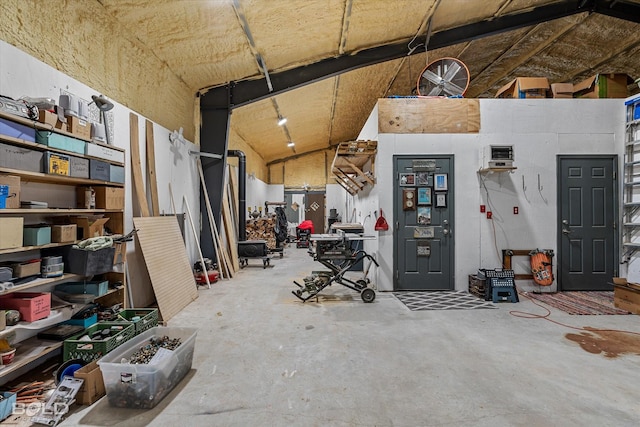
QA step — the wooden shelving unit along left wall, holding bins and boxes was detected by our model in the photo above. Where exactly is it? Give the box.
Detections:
[0,113,126,385]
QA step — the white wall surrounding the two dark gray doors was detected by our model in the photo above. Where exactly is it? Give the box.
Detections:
[345,99,624,290]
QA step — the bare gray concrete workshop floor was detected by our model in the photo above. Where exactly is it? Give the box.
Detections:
[61,247,640,427]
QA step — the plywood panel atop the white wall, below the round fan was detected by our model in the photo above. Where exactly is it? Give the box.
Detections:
[378,98,480,133]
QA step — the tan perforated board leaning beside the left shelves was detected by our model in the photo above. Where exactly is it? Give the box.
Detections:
[133,216,198,322]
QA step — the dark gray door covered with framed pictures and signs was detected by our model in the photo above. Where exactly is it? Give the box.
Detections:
[393,155,454,291]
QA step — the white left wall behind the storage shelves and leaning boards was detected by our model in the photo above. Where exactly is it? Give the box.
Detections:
[0,40,200,262]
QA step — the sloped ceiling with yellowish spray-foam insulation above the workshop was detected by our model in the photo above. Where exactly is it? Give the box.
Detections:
[99,0,640,163]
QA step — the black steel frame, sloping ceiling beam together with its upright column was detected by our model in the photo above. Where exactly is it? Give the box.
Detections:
[199,0,640,251]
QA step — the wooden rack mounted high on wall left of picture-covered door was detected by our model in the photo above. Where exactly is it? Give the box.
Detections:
[331,141,378,195]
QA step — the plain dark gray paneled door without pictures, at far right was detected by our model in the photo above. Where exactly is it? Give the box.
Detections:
[557,156,618,291]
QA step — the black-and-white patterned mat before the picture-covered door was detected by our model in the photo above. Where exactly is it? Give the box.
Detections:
[393,291,498,311]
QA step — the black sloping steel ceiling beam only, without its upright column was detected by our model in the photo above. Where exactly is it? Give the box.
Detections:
[201,0,600,110]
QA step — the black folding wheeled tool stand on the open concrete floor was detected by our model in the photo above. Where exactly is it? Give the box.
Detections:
[292,230,378,303]
